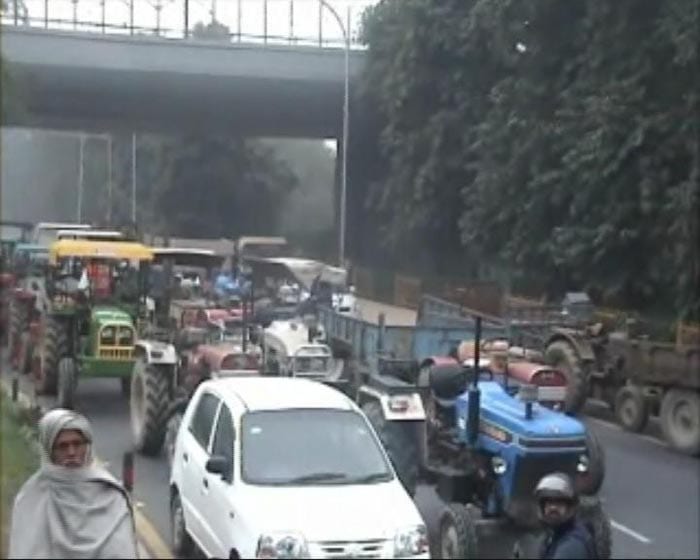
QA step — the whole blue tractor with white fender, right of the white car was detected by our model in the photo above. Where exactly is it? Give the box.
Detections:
[358,317,611,558]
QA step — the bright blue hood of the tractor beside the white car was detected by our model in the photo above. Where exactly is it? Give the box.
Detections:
[457,381,586,441]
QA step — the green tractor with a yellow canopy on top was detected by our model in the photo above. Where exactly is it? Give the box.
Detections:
[32,239,153,408]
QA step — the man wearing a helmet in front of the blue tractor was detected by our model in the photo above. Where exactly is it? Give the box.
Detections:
[535,473,597,560]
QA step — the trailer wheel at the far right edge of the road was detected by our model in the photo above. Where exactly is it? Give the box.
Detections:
[661,389,700,455]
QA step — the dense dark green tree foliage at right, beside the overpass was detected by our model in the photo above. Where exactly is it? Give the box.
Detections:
[363,0,700,320]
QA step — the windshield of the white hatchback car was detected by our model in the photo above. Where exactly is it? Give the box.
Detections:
[241,409,394,485]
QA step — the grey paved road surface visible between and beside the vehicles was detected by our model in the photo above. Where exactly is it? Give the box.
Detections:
[6,366,700,558]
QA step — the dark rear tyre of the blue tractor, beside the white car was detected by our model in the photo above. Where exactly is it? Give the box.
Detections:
[362,400,419,496]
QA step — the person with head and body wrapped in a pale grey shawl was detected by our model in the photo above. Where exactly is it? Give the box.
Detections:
[8,408,138,558]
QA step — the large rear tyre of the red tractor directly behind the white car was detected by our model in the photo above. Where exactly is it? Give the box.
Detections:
[129,357,170,455]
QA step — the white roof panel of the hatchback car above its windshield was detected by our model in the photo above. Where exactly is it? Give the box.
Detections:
[202,377,354,411]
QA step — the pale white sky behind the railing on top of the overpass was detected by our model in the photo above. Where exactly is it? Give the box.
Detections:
[17,0,379,41]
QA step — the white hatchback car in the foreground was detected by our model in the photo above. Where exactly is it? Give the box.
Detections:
[170,377,430,558]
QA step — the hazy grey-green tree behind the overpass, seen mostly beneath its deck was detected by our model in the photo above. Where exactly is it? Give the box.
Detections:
[98,22,297,241]
